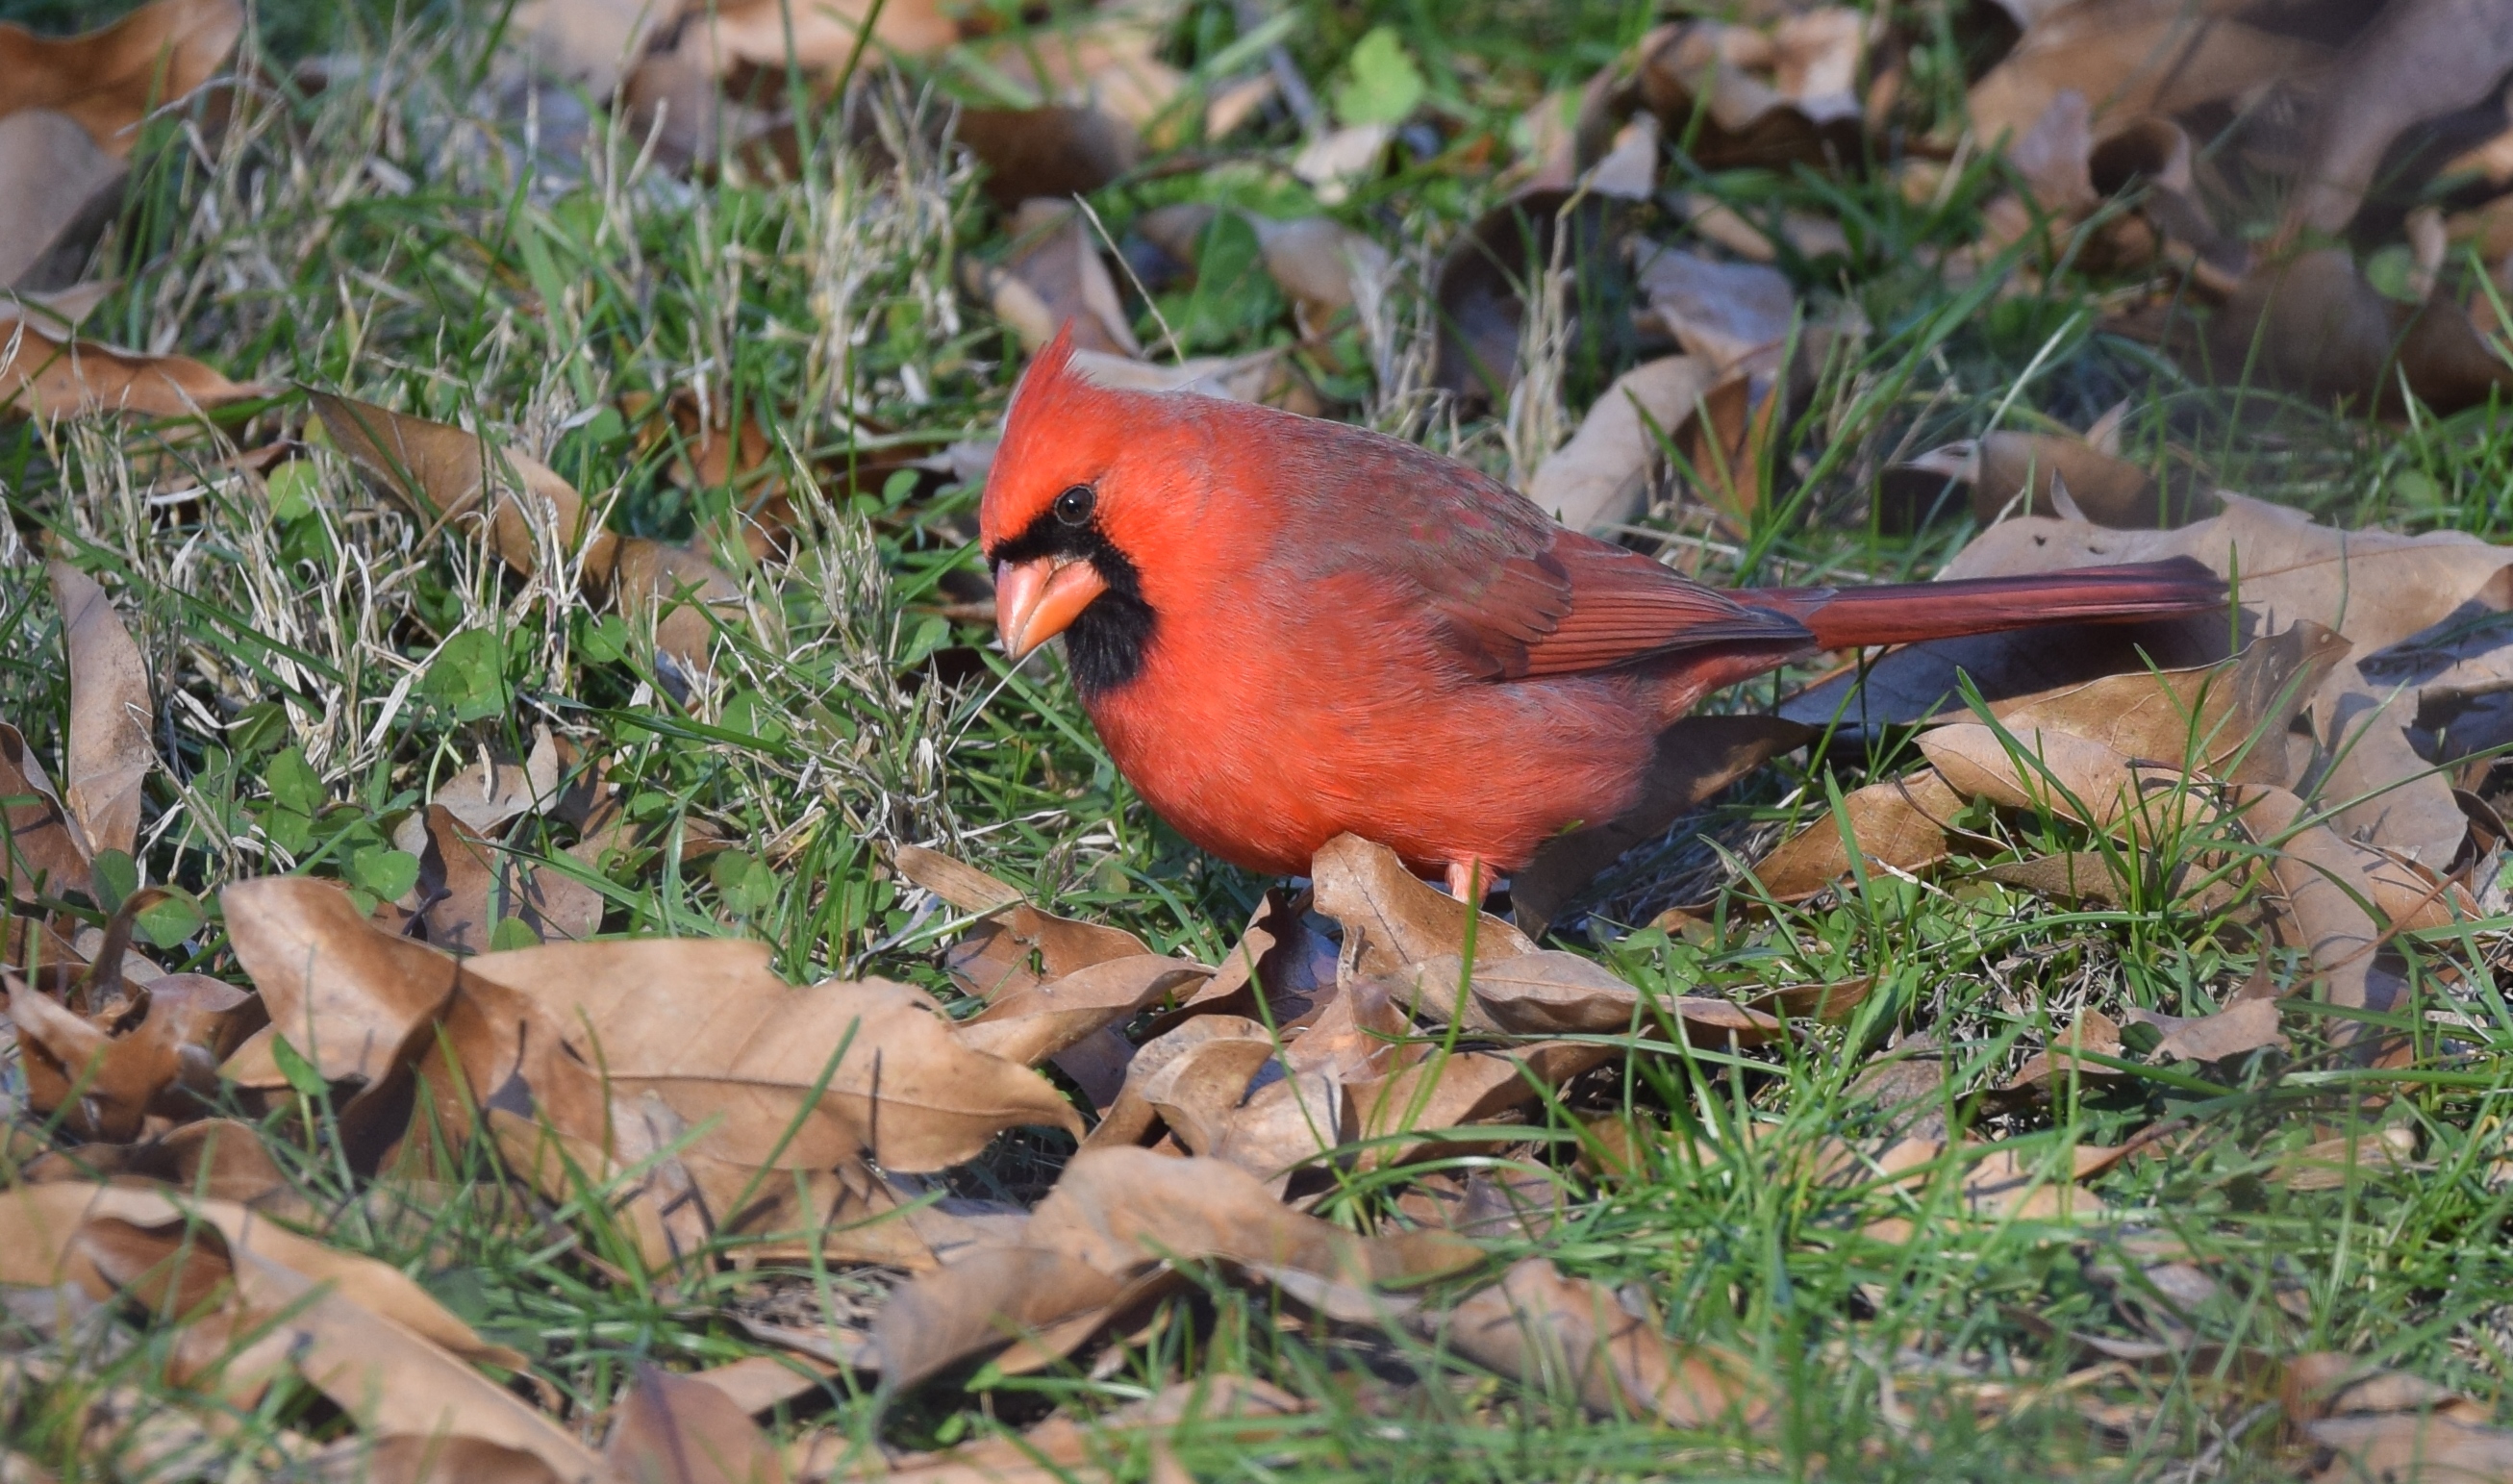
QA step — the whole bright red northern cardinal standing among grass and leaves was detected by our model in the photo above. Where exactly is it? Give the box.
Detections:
[977,337,2224,896]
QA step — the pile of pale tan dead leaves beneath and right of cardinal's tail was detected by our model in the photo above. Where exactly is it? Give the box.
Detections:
[1756,494,2513,1055]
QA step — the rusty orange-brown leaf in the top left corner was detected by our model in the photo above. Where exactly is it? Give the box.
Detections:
[0,0,243,156]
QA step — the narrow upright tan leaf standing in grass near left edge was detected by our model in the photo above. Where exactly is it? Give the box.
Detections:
[45,560,156,854]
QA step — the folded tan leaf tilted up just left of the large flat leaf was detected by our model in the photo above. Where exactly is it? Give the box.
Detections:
[218,876,455,1087]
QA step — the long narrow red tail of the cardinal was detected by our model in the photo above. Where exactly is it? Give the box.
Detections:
[1737,558,2226,650]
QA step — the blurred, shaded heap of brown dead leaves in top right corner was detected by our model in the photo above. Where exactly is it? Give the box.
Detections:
[1949,0,2513,412]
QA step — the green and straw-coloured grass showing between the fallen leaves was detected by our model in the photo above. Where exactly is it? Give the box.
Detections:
[0,0,2513,1479]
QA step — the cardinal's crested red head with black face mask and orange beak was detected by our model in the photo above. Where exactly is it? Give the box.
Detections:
[977,332,1173,695]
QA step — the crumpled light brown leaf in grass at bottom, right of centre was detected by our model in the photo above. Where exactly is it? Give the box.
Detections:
[1440,1258,1770,1429]
